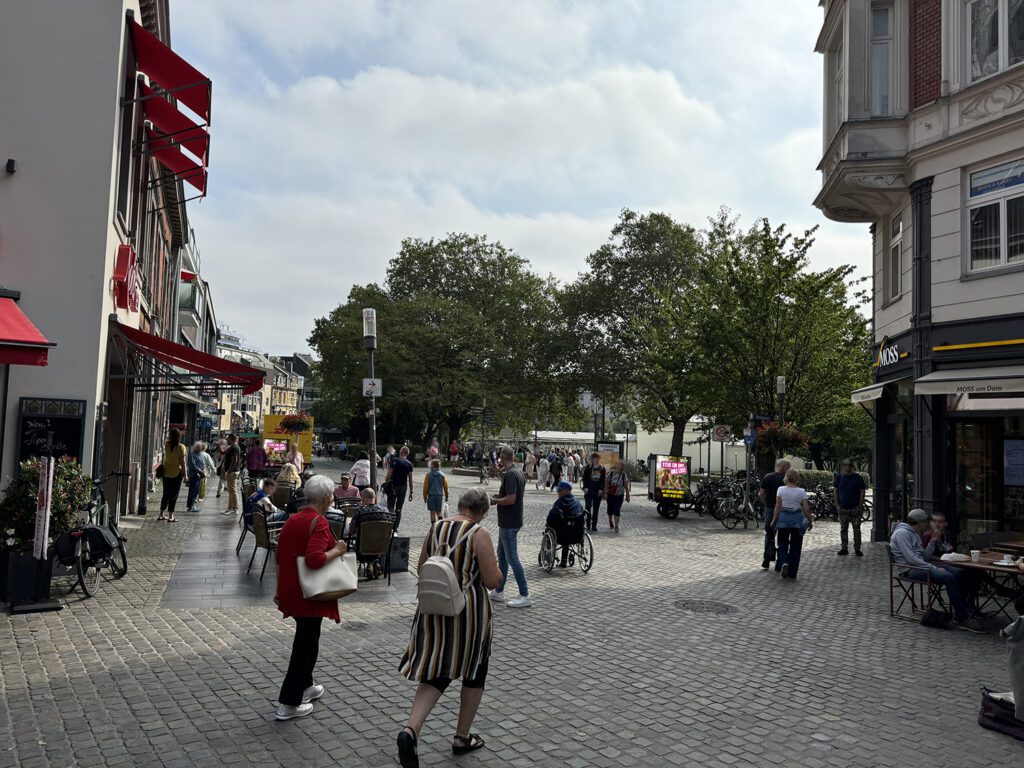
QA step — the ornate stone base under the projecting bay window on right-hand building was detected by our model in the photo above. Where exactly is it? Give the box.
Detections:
[814,118,907,222]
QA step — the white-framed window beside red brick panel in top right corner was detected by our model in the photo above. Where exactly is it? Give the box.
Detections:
[967,0,1024,81]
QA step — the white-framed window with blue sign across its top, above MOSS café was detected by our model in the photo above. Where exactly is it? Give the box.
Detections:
[967,160,1024,271]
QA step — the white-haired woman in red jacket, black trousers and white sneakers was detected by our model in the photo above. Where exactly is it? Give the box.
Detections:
[273,475,346,720]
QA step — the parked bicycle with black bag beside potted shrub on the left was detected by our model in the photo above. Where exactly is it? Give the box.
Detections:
[53,472,128,597]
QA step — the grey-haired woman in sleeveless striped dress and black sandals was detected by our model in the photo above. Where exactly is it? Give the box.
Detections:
[398,488,502,768]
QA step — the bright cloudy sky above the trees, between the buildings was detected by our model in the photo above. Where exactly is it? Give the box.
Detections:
[171,0,869,354]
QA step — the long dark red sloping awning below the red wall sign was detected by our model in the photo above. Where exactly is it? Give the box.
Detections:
[111,317,265,397]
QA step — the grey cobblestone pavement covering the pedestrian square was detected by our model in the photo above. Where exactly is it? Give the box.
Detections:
[0,465,1024,768]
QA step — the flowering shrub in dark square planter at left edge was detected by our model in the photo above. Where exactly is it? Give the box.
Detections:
[0,456,92,603]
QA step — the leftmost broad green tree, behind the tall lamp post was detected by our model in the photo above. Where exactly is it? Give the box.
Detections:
[309,233,572,444]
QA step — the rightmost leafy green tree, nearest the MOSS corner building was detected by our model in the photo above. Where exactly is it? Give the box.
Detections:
[701,210,869,469]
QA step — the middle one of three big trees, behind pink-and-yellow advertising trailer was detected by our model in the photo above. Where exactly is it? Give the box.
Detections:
[562,210,707,455]
